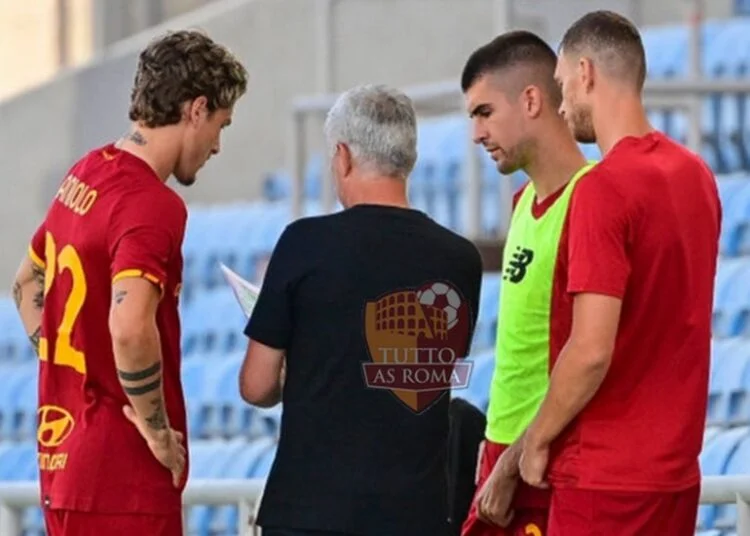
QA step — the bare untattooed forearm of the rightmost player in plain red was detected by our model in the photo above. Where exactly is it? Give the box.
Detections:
[527,345,609,446]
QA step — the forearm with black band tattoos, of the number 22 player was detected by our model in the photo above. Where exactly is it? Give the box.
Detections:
[113,325,169,440]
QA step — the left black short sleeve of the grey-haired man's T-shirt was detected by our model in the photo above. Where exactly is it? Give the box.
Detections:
[245,224,304,350]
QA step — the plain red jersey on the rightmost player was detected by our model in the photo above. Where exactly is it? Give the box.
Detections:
[549,133,721,491]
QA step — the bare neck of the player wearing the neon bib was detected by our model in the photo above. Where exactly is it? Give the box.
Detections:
[525,133,586,202]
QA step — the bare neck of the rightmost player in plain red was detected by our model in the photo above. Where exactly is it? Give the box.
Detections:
[593,94,653,155]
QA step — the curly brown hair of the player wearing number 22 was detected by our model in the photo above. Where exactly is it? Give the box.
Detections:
[128,30,248,128]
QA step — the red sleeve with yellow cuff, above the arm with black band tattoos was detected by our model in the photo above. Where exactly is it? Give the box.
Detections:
[110,186,187,289]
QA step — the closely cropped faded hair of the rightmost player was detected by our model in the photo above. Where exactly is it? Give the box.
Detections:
[560,10,646,89]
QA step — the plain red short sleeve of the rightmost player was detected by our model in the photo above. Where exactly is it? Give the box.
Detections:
[568,172,630,298]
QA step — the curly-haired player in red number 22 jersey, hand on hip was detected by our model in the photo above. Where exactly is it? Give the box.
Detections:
[13,31,247,536]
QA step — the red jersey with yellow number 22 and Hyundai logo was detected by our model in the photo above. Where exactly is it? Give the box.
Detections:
[29,145,187,514]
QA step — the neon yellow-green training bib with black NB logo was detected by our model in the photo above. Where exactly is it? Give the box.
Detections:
[486,163,594,445]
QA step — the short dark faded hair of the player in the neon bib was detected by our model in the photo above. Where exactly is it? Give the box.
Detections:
[461,30,560,106]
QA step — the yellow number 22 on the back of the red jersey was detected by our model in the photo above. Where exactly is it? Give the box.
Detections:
[39,231,87,374]
